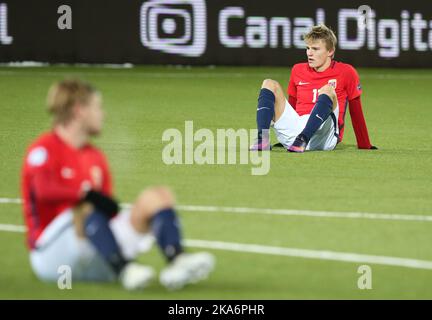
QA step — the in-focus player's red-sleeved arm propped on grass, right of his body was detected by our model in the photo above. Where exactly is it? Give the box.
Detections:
[349,96,377,149]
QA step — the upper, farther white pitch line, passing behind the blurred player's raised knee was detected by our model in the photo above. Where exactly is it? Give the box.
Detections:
[0,198,432,222]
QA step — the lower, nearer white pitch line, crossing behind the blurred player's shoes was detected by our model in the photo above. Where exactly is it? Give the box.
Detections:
[0,224,432,270]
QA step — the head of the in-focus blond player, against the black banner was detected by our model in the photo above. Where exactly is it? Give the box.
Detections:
[304,24,337,71]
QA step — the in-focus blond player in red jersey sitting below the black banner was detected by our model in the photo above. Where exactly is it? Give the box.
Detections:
[250,25,376,152]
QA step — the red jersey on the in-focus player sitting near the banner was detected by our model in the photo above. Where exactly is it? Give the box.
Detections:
[288,61,362,135]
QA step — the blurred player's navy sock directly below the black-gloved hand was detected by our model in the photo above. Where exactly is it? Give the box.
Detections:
[85,211,128,275]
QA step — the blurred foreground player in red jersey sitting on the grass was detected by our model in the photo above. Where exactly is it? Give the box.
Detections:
[22,80,214,290]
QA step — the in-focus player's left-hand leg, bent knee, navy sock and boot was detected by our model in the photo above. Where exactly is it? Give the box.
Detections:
[250,79,285,151]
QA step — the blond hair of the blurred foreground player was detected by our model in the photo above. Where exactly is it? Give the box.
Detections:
[47,79,97,124]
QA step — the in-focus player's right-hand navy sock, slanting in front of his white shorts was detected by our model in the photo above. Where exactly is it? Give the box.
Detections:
[299,94,333,142]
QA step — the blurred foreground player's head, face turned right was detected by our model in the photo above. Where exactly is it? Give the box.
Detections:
[47,80,104,136]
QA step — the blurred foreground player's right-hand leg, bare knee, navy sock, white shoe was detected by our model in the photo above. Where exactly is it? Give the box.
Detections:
[131,187,214,289]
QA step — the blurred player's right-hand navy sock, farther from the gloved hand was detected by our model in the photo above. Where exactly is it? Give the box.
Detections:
[151,208,183,262]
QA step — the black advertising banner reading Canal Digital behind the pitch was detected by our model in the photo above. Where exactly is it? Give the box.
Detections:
[0,0,432,67]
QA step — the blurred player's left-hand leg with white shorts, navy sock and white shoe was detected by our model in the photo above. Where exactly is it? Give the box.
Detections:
[30,209,154,289]
